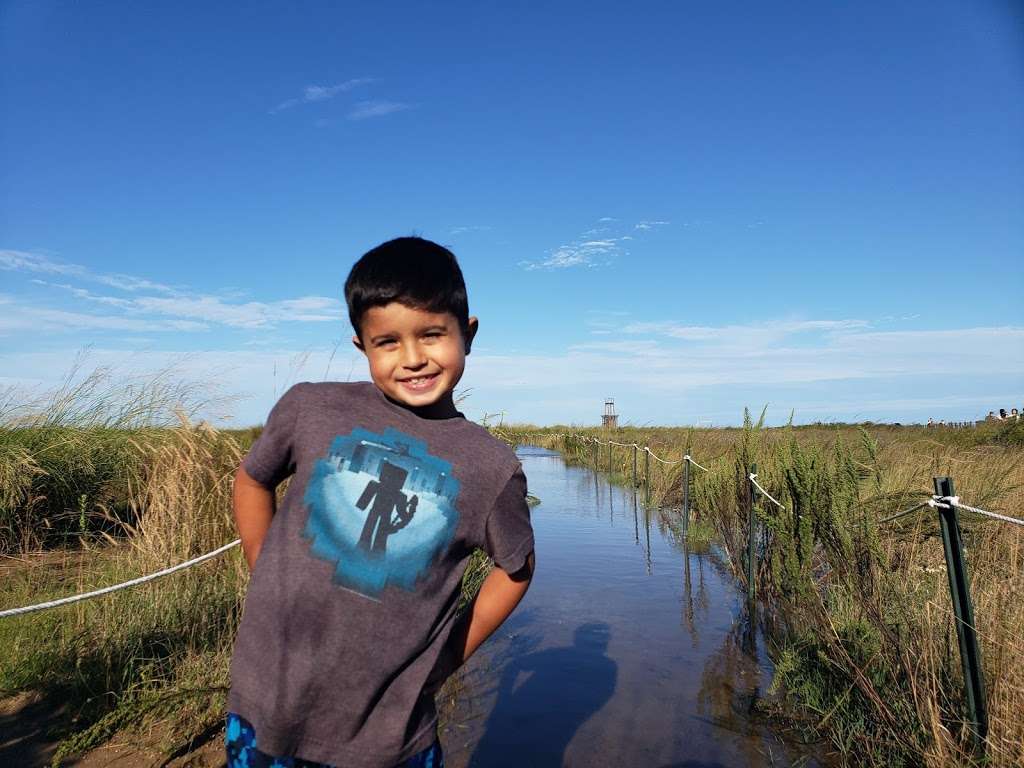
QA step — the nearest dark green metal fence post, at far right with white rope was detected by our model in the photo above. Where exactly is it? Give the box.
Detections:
[932,477,988,753]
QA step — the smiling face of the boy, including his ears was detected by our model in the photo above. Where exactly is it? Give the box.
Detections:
[352,301,477,415]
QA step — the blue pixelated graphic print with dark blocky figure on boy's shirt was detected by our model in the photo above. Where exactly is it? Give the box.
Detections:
[303,427,459,597]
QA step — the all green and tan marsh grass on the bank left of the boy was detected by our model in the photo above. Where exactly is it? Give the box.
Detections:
[0,367,490,764]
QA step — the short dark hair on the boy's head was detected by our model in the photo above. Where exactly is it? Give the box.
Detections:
[345,238,469,338]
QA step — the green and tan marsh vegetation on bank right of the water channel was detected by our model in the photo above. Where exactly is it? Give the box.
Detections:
[505,416,1024,767]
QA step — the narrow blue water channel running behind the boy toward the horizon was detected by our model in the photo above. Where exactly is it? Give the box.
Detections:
[441,446,816,768]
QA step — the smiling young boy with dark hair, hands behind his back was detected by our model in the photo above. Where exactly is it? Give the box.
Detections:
[226,238,534,768]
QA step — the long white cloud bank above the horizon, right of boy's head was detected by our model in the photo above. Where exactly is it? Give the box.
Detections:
[464,321,1024,397]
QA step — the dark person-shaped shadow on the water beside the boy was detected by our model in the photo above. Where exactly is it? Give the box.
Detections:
[469,622,617,768]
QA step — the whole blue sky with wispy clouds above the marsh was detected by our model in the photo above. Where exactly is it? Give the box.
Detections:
[0,0,1024,424]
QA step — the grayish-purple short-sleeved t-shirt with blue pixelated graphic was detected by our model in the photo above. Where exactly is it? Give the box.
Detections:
[227,382,534,768]
